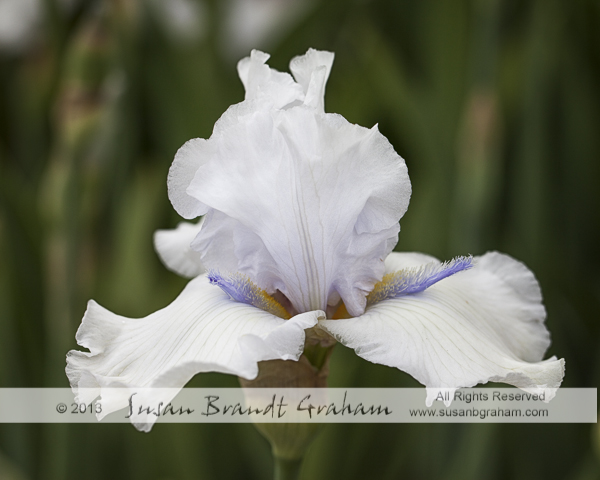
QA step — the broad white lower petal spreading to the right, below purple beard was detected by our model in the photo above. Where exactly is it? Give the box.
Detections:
[319,252,564,403]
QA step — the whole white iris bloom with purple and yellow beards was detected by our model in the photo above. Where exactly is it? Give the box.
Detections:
[67,49,564,432]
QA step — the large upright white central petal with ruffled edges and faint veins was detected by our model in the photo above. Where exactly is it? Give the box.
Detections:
[169,107,410,315]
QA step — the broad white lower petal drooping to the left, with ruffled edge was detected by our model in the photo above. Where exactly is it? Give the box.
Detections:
[66,276,325,429]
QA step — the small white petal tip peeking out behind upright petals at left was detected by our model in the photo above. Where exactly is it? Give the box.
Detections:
[154,217,206,278]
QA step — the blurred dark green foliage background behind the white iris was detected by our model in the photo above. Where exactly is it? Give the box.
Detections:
[0,0,600,480]
